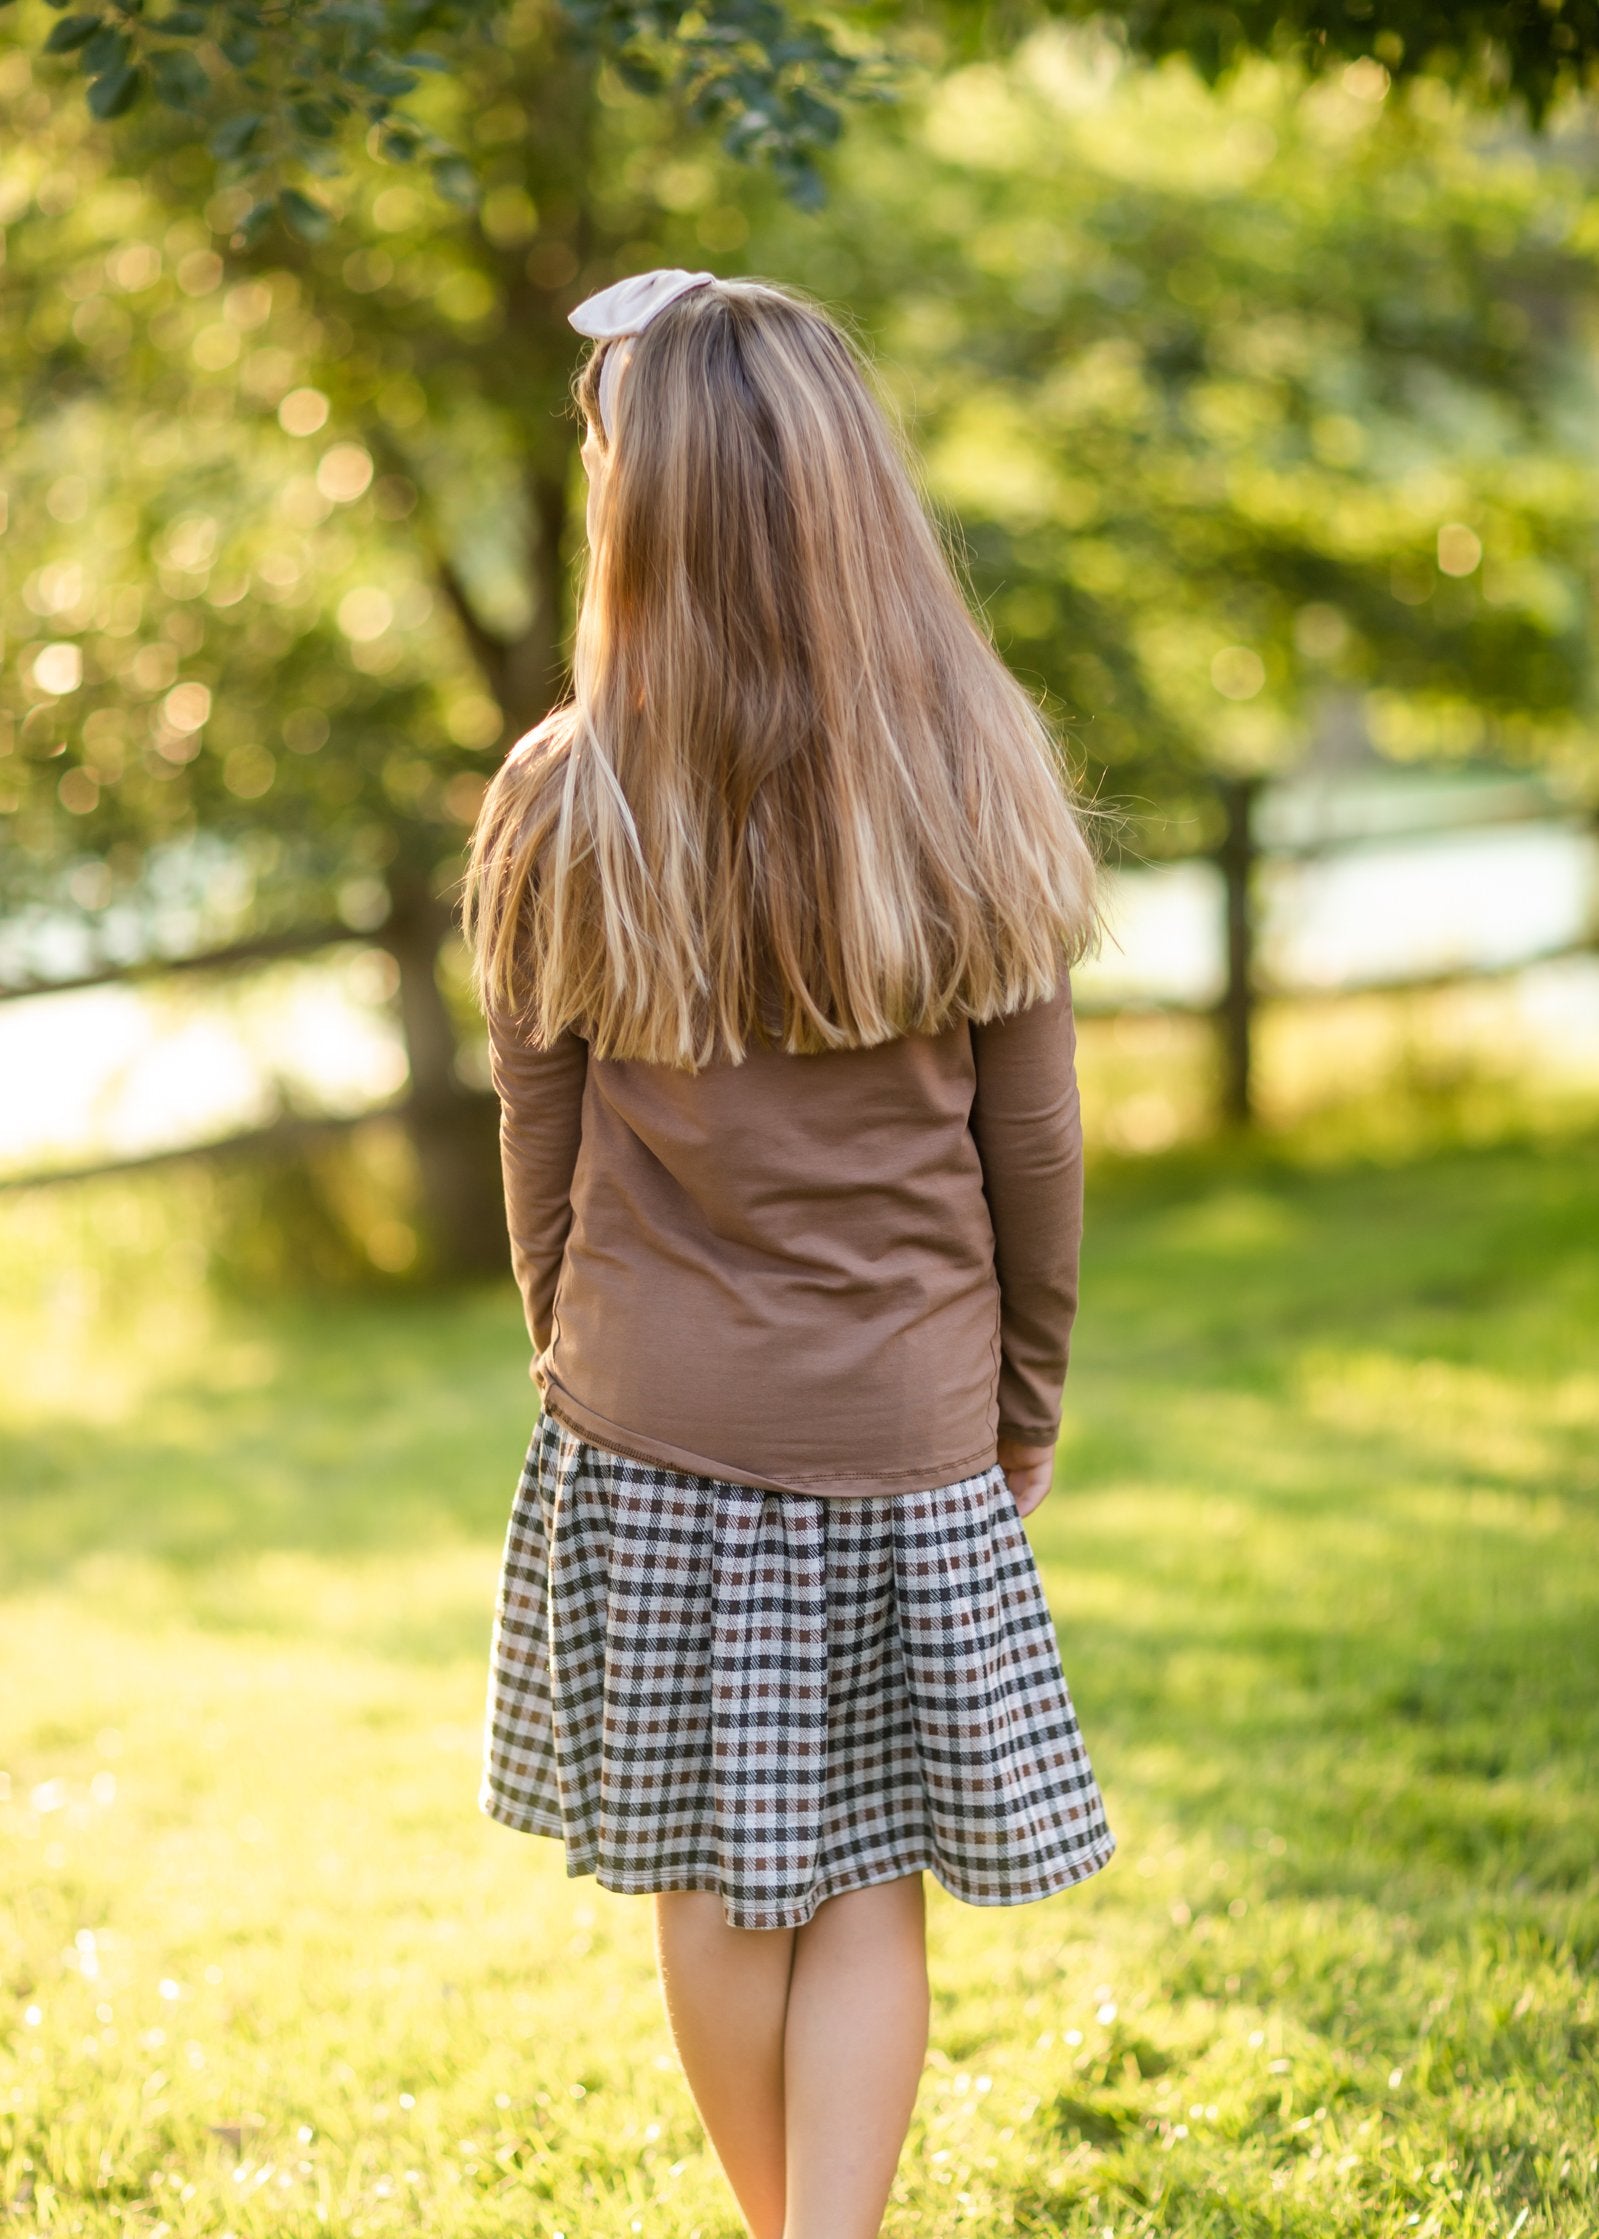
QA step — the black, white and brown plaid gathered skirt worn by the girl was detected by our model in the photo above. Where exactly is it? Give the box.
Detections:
[479,1415,1115,1928]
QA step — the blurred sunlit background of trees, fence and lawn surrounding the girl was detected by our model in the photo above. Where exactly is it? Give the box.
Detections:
[0,17,1599,2239]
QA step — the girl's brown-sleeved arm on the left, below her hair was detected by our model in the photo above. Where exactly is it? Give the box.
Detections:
[488,1010,589,1377]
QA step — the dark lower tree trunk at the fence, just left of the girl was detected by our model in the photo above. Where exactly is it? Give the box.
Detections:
[383,878,508,1274]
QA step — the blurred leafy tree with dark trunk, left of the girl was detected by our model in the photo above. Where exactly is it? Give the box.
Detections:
[0,9,739,1263]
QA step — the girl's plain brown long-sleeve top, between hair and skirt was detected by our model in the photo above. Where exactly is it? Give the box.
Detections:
[488,974,1082,1496]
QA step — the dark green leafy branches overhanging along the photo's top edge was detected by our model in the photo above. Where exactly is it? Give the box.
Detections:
[21,0,1599,244]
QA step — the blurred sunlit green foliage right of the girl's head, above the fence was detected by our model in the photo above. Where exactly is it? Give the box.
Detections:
[752,31,1599,851]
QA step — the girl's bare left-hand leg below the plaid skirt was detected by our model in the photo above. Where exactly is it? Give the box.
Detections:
[656,1890,792,2239]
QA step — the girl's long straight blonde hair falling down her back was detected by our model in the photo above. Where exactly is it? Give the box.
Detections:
[464,282,1097,1070]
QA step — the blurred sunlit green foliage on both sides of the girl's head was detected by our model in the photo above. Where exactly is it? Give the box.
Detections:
[0,31,1599,952]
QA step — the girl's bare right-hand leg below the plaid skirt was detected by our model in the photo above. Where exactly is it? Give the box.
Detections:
[782,1874,929,2239]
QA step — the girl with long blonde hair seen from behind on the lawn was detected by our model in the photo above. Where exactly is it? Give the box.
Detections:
[466,271,1115,2239]
